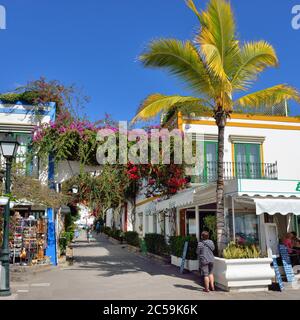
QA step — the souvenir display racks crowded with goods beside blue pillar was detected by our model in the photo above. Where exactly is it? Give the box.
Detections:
[9,206,50,266]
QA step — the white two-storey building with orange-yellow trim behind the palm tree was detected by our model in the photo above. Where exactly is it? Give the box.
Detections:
[121,114,300,253]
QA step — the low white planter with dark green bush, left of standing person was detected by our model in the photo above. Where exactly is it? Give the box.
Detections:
[170,236,199,271]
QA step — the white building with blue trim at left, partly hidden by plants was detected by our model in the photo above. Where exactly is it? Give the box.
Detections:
[0,102,57,265]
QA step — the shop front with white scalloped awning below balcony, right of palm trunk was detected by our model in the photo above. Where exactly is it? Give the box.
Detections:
[225,180,300,257]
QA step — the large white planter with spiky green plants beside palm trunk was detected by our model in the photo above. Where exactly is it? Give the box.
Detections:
[214,242,275,292]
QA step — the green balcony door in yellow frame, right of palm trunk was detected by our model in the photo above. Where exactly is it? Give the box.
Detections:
[235,143,262,179]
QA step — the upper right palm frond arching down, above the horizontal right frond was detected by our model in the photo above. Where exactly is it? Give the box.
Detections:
[231,41,278,90]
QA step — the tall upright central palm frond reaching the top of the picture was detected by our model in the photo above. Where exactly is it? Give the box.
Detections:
[196,0,240,82]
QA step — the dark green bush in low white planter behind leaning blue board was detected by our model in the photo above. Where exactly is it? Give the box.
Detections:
[170,236,198,260]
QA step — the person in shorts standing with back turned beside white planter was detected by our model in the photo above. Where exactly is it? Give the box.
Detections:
[198,231,215,292]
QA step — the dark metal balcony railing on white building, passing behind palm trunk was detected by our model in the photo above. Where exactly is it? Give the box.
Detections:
[192,161,278,183]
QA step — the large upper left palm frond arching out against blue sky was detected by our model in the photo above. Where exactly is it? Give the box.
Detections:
[140,39,213,94]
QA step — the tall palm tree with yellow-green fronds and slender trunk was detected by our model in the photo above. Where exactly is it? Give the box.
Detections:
[133,0,300,253]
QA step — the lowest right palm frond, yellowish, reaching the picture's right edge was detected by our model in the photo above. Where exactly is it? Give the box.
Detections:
[235,84,300,108]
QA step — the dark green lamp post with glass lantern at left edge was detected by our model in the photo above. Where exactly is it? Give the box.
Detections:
[0,135,19,296]
